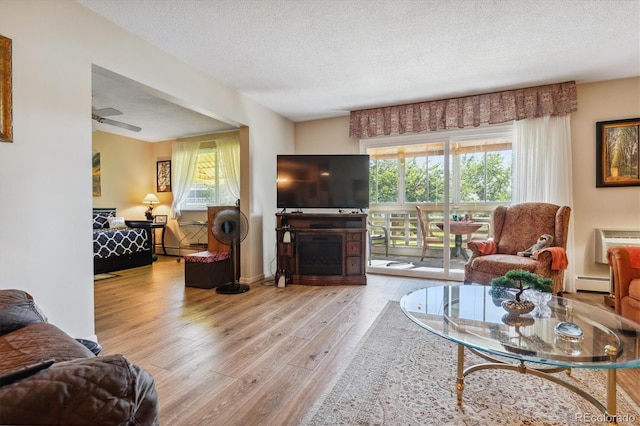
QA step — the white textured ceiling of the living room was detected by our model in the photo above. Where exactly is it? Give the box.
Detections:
[81,0,640,141]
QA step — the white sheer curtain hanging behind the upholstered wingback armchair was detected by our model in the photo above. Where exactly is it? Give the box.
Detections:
[513,114,576,292]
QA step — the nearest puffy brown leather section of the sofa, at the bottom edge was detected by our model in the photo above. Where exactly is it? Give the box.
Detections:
[0,355,158,425]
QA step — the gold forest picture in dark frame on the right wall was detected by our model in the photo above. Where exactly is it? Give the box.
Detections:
[596,118,640,188]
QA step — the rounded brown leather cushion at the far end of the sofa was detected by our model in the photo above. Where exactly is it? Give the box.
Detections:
[0,289,47,335]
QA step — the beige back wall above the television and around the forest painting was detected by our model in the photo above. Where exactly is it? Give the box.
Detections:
[295,78,640,288]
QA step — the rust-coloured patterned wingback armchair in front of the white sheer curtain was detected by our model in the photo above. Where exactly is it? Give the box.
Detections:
[464,203,571,294]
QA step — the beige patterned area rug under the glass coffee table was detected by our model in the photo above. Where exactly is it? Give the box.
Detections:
[302,302,640,426]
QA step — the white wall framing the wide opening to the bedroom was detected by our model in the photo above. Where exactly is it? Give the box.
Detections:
[0,0,293,336]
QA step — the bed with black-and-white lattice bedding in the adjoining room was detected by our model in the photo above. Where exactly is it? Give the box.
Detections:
[93,208,152,274]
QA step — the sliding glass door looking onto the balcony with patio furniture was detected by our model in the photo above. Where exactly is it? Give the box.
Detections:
[361,126,511,280]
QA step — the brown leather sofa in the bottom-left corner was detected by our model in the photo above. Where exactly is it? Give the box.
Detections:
[0,290,158,425]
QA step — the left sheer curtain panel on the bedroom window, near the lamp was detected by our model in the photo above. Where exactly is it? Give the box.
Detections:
[171,141,200,219]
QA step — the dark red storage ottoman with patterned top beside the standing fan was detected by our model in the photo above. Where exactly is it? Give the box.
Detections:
[184,251,233,288]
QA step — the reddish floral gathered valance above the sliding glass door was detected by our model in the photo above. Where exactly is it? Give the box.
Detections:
[349,81,578,138]
